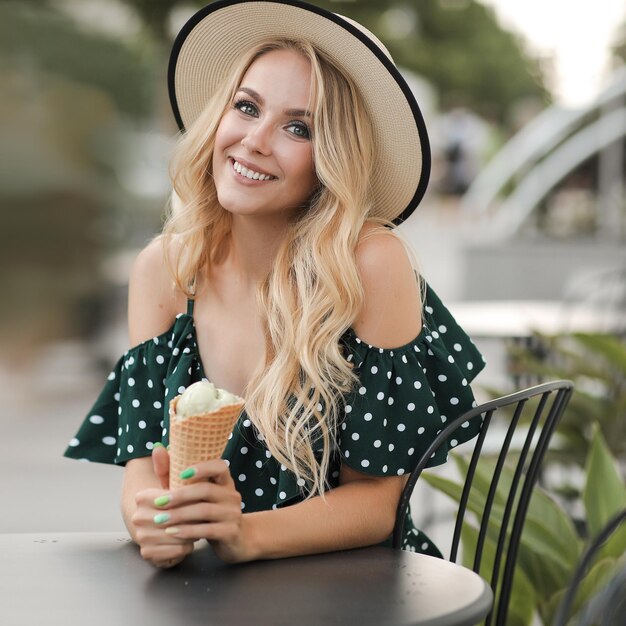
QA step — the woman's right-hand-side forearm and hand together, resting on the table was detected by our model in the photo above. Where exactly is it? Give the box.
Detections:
[149,460,406,563]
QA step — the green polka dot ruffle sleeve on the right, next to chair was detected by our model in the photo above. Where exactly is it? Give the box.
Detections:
[339,280,484,476]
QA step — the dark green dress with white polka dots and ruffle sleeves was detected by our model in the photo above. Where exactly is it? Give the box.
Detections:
[65,280,484,556]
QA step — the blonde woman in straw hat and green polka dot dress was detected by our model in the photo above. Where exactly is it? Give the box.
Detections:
[66,1,482,567]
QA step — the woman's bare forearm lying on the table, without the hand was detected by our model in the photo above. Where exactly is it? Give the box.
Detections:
[242,480,399,560]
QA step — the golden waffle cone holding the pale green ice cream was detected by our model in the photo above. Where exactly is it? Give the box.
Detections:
[169,396,243,489]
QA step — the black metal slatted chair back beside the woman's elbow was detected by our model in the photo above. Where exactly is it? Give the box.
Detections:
[392,380,574,626]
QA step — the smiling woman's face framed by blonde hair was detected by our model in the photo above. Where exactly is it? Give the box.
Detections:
[213,50,317,216]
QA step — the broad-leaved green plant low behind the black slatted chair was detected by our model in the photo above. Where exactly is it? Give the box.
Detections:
[423,424,626,626]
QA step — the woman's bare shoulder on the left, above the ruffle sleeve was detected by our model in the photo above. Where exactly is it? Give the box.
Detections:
[128,237,185,345]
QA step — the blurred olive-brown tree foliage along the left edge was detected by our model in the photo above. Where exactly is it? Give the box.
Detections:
[0,0,158,355]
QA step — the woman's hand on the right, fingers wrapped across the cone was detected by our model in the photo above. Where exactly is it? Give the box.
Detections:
[153,460,251,563]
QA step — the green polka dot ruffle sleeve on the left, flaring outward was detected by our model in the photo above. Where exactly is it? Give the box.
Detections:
[65,314,201,465]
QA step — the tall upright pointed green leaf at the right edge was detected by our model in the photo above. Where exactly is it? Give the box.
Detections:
[583,423,626,536]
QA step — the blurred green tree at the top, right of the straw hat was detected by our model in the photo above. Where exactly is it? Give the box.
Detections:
[318,0,550,123]
